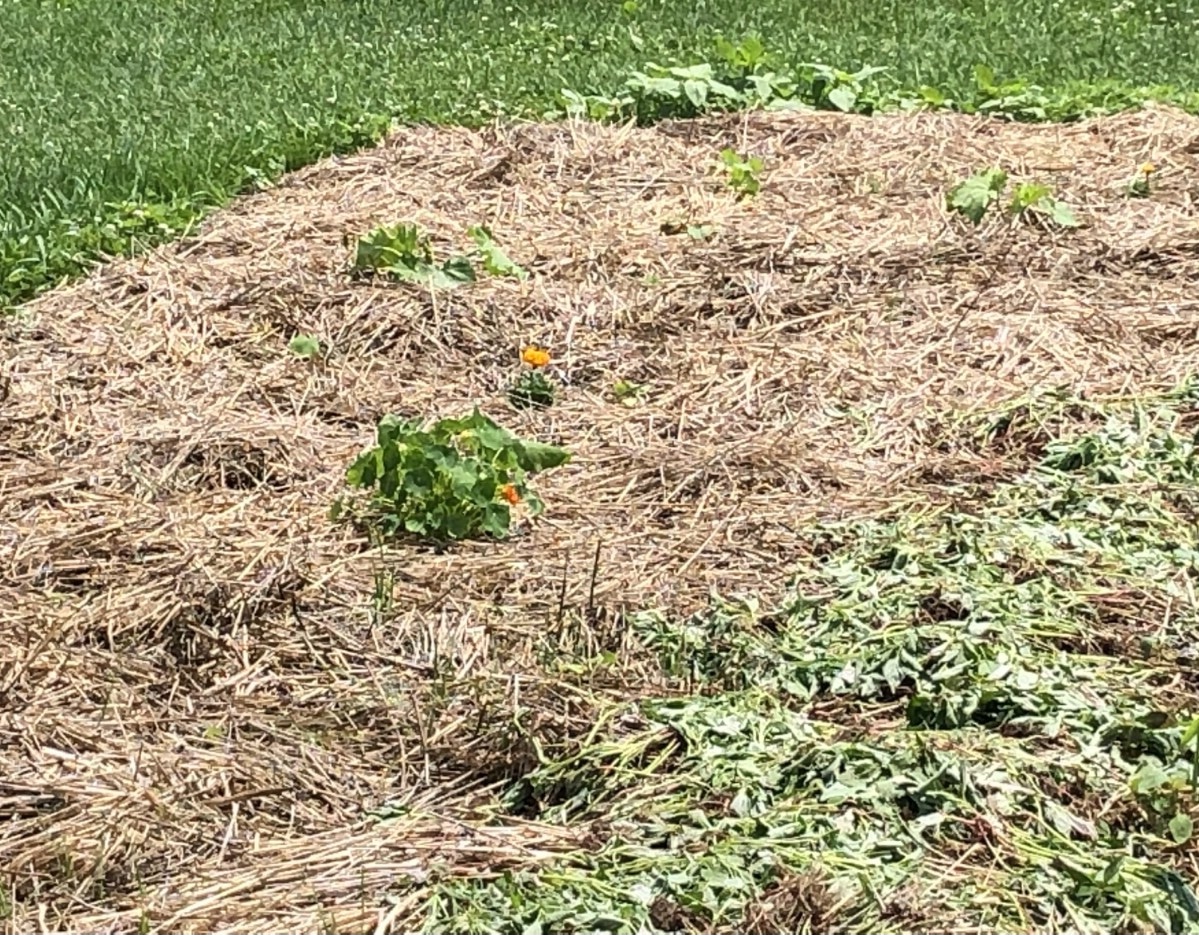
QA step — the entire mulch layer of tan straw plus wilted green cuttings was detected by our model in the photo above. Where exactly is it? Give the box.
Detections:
[0,109,1199,933]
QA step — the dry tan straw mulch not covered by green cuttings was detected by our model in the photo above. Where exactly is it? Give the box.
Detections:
[0,102,1199,933]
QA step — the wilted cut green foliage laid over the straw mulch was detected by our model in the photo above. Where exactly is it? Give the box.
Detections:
[423,381,1199,935]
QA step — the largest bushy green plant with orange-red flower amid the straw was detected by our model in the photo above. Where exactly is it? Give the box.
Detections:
[335,406,571,539]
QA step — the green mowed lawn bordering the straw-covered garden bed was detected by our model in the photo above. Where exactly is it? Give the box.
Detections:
[0,0,1199,303]
